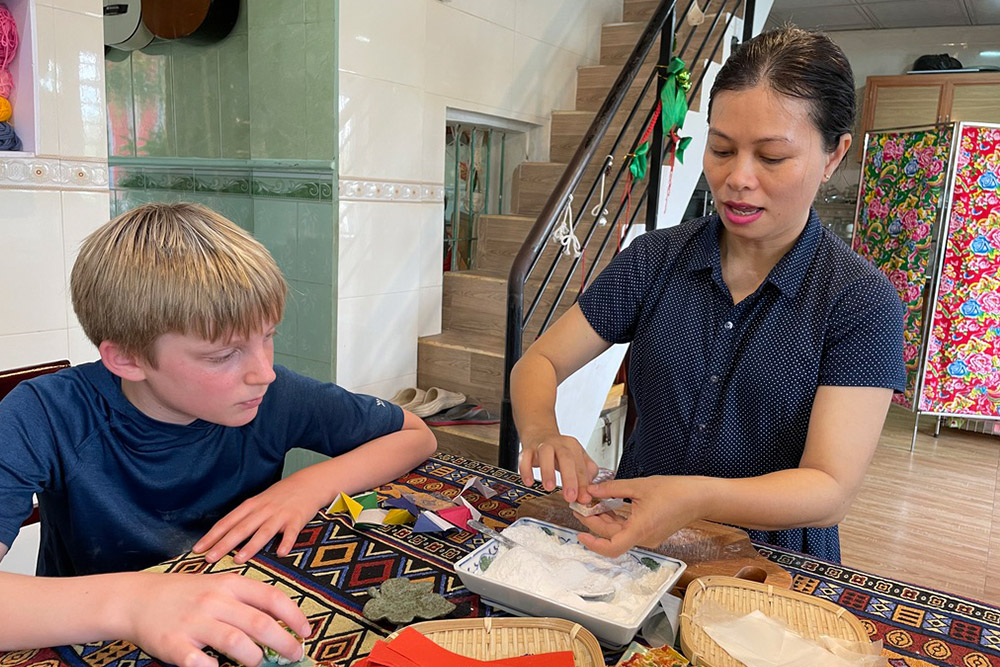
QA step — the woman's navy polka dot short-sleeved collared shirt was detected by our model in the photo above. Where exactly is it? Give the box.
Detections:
[580,211,906,562]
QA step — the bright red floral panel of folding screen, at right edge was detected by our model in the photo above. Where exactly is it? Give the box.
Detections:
[919,123,1000,418]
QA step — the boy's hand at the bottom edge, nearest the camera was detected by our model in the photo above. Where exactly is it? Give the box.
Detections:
[123,572,312,667]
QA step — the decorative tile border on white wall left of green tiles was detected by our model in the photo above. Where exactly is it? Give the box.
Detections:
[0,159,108,191]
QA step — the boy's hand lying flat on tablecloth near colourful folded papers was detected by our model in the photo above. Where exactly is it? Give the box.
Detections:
[192,475,323,563]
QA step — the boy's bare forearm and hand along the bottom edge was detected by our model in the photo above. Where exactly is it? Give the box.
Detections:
[0,564,311,667]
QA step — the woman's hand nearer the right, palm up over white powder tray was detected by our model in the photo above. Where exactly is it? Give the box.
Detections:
[576,475,704,558]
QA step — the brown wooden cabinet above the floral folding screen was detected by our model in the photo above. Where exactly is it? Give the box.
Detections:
[855,72,1000,158]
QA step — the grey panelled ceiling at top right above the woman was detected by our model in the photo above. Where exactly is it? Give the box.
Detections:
[766,0,1000,31]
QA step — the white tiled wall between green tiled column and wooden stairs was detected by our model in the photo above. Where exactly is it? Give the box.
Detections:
[337,0,622,396]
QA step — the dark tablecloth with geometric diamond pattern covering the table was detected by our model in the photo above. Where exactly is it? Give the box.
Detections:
[0,454,1000,667]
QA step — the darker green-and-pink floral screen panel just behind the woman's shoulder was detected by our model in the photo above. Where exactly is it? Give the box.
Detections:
[851,127,953,408]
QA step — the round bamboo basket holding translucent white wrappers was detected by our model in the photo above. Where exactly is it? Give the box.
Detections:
[680,576,868,667]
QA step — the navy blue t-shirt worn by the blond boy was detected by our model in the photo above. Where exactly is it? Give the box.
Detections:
[0,362,403,576]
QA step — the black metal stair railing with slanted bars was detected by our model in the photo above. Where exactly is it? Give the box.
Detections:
[499,0,754,470]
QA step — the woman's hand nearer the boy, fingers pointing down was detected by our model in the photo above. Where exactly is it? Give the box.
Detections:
[518,433,598,503]
